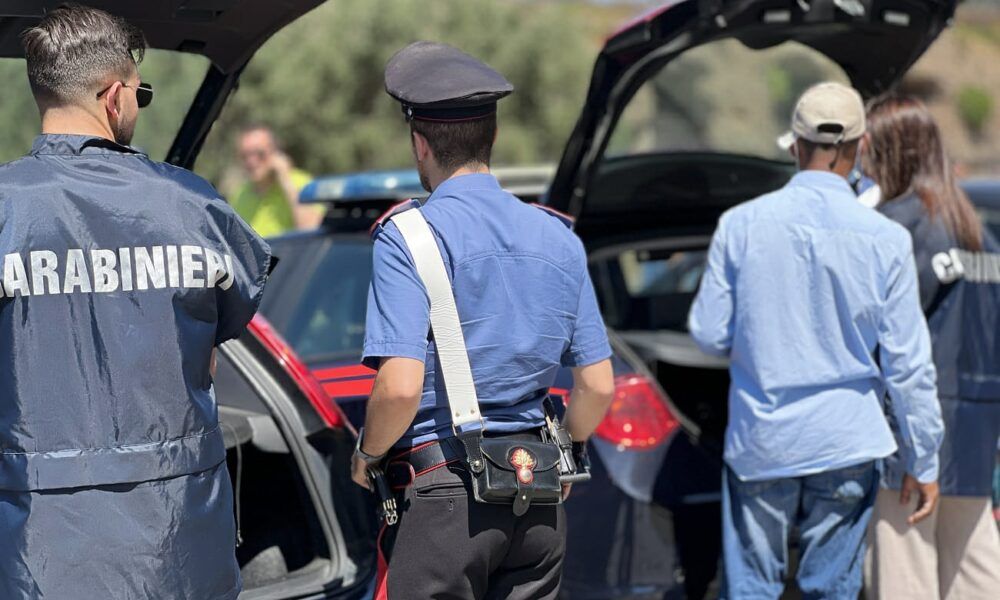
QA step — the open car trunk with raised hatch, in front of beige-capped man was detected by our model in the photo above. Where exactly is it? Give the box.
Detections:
[547,0,956,440]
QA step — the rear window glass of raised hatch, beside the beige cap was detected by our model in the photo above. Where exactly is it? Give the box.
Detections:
[606,40,848,159]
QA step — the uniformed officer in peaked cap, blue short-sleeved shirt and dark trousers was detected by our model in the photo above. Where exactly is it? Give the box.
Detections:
[353,42,614,600]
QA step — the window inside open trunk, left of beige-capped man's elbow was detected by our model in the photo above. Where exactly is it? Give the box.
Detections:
[591,248,707,331]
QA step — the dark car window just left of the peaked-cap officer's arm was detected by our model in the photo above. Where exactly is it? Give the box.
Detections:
[281,236,372,362]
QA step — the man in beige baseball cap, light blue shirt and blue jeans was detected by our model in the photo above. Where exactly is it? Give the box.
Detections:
[689,83,943,598]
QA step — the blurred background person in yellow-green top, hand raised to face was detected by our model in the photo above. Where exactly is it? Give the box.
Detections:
[232,126,322,237]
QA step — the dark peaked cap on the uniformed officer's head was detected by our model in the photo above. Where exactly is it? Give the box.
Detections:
[385,42,514,122]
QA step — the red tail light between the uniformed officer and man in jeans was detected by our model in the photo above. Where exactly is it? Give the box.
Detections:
[594,374,680,450]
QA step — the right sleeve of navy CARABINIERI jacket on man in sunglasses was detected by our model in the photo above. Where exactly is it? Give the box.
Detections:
[209,207,271,345]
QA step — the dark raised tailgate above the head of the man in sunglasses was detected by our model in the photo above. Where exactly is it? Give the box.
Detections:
[0,0,324,73]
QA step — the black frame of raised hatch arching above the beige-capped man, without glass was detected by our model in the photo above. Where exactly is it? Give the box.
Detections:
[549,0,956,216]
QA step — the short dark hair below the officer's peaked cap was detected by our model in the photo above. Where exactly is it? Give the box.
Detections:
[410,113,497,170]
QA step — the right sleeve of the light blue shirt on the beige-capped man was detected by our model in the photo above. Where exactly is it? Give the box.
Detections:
[879,234,944,483]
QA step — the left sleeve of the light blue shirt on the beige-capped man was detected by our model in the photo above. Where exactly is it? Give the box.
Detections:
[688,215,735,356]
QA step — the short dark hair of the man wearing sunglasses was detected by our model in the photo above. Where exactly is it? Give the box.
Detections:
[21,4,146,103]
